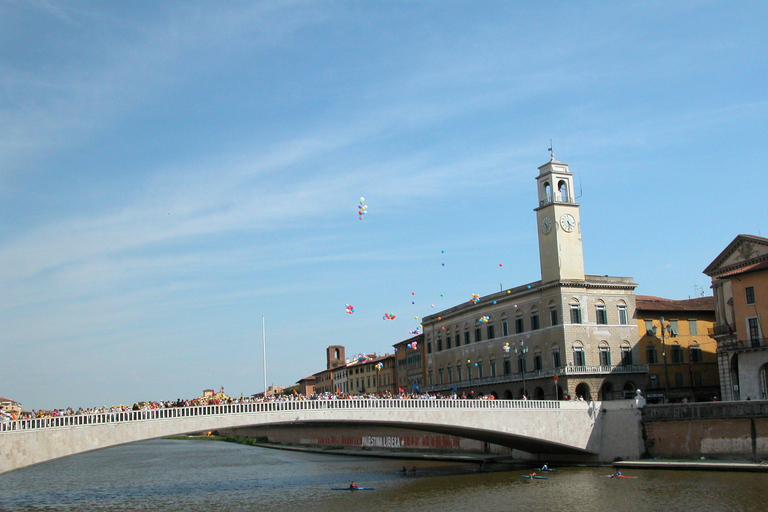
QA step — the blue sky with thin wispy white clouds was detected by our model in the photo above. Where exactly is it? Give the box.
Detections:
[0,0,768,409]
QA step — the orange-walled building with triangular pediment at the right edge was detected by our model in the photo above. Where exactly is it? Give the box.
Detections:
[704,235,768,400]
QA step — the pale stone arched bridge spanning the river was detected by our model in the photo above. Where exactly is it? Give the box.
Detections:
[0,399,642,473]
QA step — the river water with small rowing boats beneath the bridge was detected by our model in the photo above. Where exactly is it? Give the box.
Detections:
[0,440,768,512]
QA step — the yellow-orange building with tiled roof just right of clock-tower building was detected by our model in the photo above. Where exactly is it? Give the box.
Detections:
[635,295,720,403]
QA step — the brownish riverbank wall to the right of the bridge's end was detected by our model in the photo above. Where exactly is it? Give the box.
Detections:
[641,400,768,461]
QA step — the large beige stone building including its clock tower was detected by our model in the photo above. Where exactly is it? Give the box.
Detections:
[422,155,647,400]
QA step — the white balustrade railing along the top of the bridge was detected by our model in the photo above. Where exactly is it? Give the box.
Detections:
[0,398,560,433]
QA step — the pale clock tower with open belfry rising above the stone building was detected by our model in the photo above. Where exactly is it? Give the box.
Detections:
[534,154,584,283]
